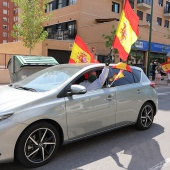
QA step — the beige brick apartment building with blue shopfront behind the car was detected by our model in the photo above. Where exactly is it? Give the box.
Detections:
[0,0,170,83]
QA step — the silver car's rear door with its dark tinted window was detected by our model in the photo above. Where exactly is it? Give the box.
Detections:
[108,69,142,127]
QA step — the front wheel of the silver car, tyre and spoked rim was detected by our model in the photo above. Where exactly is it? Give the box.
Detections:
[15,122,59,168]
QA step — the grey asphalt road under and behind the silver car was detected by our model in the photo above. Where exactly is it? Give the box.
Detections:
[0,86,170,170]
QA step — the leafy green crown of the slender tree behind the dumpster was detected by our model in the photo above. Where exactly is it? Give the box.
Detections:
[11,0,51,55]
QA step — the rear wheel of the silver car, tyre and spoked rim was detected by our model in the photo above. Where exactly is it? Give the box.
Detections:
[136,102,154,130]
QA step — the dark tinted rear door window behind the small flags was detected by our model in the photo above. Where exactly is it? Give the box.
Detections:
[108,69,136,87]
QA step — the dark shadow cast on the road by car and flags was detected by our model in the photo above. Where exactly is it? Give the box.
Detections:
[0,124,164,170]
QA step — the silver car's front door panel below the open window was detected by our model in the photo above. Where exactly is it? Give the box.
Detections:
[65,88,116,139]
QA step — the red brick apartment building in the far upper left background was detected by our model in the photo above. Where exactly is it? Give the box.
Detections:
[0,0,18,44]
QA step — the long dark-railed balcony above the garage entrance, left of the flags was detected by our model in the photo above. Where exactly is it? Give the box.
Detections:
[47,29,77,40]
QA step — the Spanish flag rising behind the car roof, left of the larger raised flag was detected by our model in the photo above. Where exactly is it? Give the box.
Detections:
[69,35,94,63]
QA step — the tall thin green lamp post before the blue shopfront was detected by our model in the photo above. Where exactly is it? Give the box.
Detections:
[147,0,153,77]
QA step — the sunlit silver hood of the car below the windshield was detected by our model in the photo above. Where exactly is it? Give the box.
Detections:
[0,86,43,112]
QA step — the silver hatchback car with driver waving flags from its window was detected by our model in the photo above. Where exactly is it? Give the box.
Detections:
[0,64,158,167]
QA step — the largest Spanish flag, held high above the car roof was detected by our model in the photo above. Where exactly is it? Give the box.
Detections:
[112,0,139,61]
